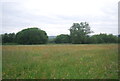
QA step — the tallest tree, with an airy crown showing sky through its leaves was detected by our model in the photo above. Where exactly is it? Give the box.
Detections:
[69,22,92,44]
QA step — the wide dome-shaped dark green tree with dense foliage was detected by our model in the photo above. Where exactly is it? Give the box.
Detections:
[16,28,48,44]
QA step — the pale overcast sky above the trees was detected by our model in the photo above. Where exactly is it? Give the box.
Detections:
[0,0,119,36]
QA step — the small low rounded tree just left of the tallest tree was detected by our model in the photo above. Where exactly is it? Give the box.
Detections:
[55,34,70,43]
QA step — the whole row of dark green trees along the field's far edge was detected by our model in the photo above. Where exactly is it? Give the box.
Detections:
[1,22,120,45]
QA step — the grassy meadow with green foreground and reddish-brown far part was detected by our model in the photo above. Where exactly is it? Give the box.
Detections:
[2,44,118,79]
